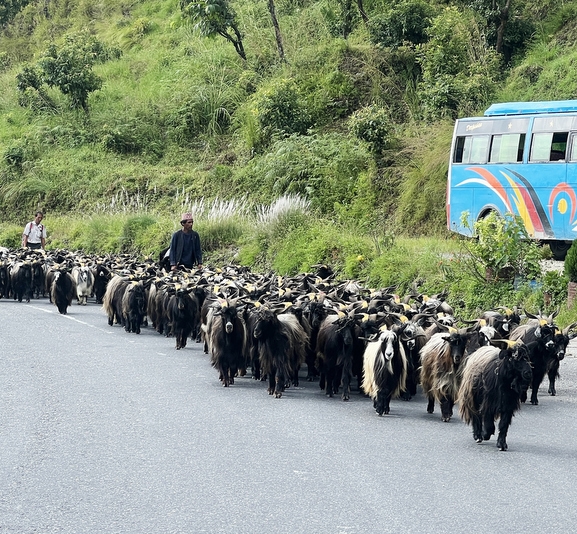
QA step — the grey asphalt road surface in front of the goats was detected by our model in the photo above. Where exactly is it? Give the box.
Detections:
[0,299,577,534]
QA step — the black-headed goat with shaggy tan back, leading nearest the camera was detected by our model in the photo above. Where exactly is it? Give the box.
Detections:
[458,341,532,451]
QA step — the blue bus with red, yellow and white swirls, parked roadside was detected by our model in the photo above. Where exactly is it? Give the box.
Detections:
[447,100,577,259]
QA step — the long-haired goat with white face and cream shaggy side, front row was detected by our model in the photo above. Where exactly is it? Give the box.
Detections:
[362,326,408,415]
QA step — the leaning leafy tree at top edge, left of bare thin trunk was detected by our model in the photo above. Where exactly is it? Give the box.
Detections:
[180,0,246,61]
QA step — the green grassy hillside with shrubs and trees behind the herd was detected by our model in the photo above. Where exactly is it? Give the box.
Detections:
[0,0,577,324]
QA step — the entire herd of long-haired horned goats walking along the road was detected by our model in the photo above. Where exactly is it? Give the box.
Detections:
[0,248,577,450]
